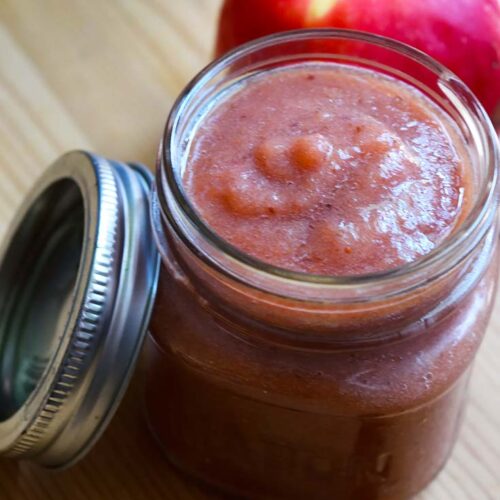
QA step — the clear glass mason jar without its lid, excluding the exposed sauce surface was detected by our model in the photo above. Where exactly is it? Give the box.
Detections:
[146,30,498,500]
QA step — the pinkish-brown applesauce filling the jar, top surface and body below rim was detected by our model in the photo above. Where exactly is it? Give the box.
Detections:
[147,60,497,500]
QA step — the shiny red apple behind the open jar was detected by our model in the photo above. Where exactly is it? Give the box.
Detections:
[216,0,500,116]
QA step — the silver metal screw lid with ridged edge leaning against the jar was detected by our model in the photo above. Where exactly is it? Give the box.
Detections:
[0,152,160,467]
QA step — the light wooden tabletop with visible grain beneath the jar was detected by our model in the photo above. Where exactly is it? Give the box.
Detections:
[0,0,500,500]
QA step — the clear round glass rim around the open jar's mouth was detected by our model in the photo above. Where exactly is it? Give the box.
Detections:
[157,28,499,296]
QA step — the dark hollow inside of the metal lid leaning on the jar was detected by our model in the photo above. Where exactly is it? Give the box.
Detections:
[0,179,85,422]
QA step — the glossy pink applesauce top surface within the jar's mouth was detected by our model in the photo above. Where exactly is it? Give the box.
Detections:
[183,63,469,275]
